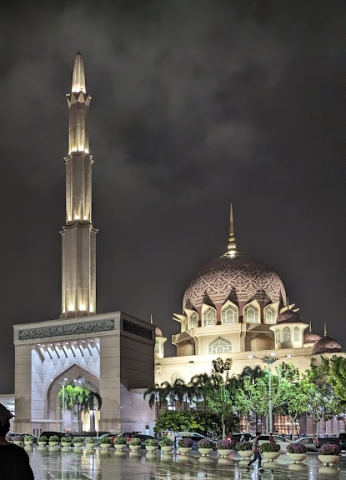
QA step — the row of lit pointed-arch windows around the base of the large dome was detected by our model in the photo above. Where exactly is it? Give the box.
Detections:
[188,300,278,329]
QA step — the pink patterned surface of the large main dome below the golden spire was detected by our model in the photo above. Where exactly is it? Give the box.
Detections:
[183,255,286,308]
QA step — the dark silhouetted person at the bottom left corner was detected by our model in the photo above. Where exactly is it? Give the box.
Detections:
[0,403,34,480]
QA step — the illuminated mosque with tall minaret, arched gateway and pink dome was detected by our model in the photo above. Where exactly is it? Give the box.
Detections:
[14,53,341,434]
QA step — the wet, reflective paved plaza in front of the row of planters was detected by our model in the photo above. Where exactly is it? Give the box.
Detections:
[25,447,346,480]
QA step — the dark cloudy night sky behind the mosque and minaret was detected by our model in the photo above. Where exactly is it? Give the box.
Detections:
[0,0,346,393]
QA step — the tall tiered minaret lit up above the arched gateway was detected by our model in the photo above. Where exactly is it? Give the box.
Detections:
[60,53,98,317]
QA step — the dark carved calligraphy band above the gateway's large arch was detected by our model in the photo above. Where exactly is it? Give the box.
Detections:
[18,319,114,340]
